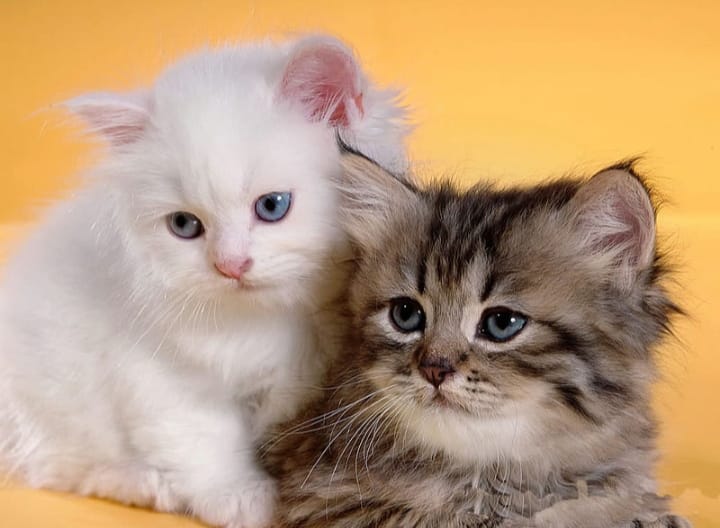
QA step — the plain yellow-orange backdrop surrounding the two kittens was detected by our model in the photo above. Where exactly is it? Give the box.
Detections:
[0,0,720,528]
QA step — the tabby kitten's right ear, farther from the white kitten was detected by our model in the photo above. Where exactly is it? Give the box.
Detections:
[571,165,655,287]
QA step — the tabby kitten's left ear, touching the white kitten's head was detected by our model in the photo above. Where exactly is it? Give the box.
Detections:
[339,150,420,250]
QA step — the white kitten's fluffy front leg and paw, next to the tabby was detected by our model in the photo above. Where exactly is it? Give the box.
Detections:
[126,384,275,528]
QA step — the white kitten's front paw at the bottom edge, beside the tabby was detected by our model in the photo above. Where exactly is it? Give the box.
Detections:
[192,478,276,528]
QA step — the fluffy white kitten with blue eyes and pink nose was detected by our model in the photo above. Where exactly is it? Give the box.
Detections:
[0,37,406,527]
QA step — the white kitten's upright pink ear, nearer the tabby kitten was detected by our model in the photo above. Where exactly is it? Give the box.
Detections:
[280,37,363,127]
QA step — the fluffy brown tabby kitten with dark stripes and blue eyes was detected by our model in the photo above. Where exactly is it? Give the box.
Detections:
[264,154,689,528]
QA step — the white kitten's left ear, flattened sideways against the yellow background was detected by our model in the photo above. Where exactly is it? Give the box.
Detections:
[64,91,150,146]
